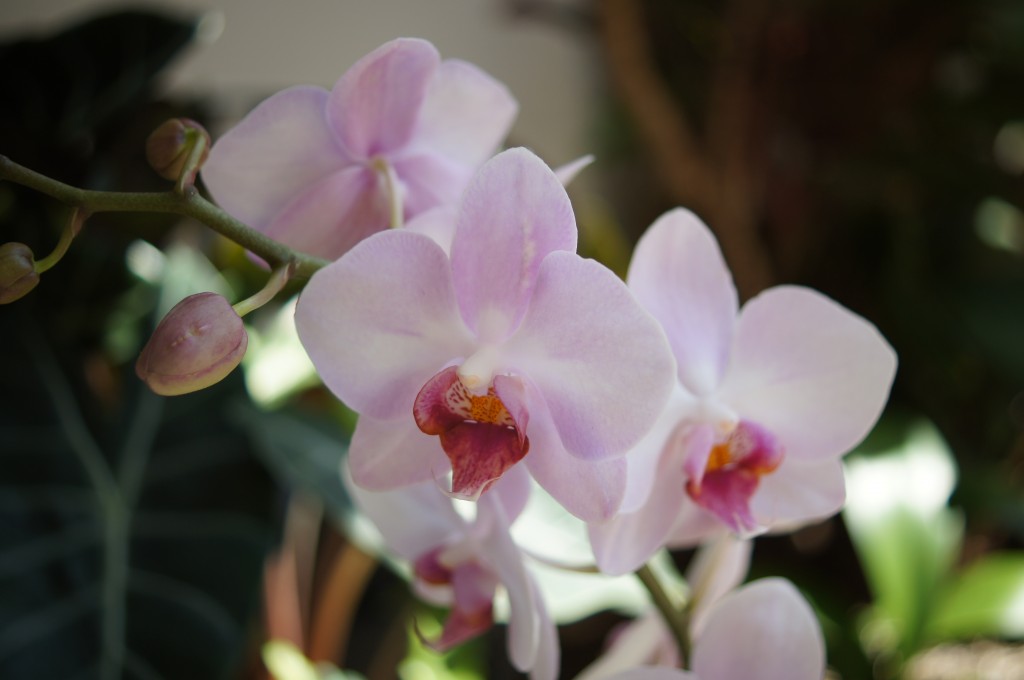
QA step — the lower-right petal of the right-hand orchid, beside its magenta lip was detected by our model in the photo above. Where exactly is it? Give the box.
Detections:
[751,459,846,529]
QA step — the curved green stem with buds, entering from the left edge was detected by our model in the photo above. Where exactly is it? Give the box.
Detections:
[0,156,328,279]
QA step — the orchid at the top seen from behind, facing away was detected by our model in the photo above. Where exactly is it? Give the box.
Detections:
[203,38,517,260]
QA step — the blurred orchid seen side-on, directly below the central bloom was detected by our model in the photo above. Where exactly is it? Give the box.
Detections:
[350,470,559,680]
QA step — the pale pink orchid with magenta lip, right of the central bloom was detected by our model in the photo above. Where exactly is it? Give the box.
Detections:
[590,209,896,573]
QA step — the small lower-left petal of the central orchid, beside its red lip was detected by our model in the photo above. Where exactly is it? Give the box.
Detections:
[348,416,452,491]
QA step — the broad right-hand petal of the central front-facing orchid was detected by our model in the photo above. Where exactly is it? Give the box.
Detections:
[505,251,675,460]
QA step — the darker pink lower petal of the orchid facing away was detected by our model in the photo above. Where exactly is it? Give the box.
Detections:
[263,166,390,260]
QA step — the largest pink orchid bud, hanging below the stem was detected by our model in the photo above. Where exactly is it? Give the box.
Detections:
[135,293,249,396]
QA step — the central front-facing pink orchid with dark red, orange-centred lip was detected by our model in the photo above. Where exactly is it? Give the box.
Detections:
[295,148,675,519]
